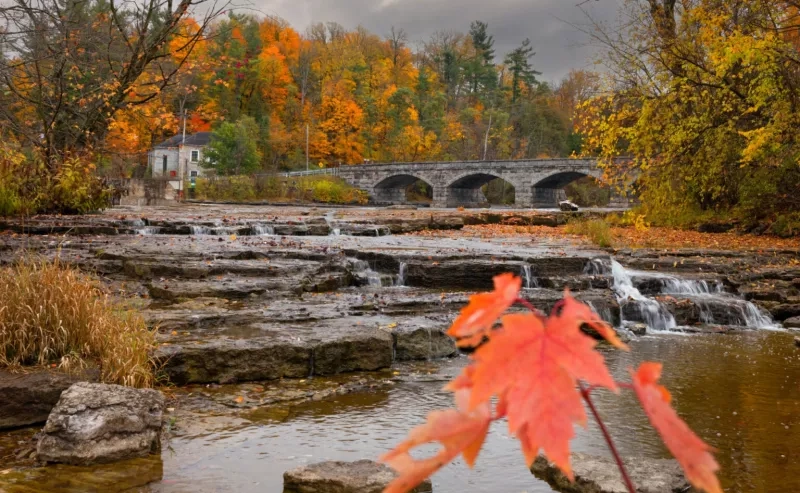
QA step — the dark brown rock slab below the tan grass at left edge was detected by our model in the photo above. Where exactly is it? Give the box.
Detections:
[0,370,97,430]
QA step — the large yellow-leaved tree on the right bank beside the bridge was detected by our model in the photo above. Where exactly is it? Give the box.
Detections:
[579,0,800,232]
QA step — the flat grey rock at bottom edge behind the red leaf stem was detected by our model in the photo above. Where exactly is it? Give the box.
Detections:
[531,452,694,493]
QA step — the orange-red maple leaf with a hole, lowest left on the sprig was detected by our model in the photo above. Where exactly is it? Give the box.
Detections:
[381,389,492,493]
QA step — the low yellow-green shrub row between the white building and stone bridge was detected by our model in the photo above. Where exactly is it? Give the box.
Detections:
[195,175,368,205]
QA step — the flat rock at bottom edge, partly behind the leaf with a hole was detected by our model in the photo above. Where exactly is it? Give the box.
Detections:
[283,460,433,493]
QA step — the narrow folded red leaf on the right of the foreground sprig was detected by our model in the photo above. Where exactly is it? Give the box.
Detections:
[630,362,722,493]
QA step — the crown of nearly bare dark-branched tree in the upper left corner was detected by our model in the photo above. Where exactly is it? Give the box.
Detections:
[0,0,225,161]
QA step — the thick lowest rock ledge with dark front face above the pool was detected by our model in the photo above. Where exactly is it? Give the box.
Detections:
[155,316,457,385]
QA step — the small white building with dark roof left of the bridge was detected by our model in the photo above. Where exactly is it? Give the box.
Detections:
[147,132,211,190]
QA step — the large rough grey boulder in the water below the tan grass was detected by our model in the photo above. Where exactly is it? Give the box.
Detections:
[37,382,164,465]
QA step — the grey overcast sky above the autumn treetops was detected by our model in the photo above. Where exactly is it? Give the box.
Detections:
[251,0,622,81]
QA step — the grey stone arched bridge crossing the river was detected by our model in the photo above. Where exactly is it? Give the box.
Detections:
[338,159,623,208]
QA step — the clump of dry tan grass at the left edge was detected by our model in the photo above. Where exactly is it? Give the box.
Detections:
[0,259,156,387]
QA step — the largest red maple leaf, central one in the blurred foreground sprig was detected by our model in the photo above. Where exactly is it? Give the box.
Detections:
[467,293,624,478]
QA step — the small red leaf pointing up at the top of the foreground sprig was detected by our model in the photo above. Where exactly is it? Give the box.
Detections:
[447,274,522,347]
